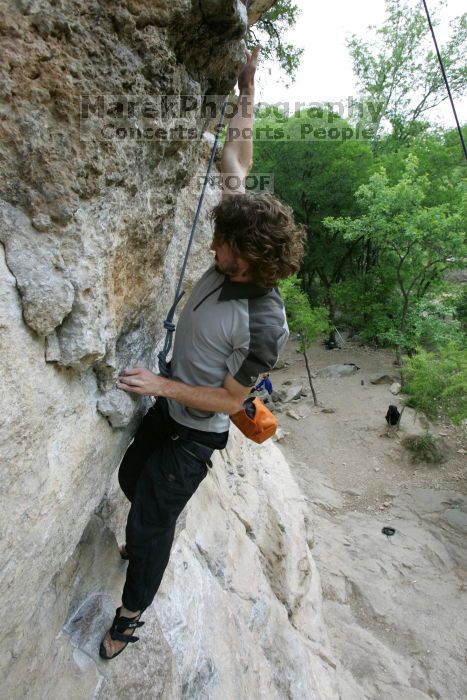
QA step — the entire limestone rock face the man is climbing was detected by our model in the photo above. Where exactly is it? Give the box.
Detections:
[0,0,340,700]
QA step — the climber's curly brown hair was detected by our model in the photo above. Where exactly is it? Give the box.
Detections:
[211,193,305,287]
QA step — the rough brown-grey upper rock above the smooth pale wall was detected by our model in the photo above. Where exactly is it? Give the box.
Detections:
[0,0,247,382]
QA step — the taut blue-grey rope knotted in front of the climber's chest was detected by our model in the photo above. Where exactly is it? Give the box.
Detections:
[157,97,227,377]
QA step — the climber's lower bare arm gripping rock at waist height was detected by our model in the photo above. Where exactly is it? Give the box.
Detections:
[117,367,250,415]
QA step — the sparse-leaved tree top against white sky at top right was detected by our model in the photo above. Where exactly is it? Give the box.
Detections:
[348,0,467,145]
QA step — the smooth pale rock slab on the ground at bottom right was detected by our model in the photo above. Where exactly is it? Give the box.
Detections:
[300,470,467,700]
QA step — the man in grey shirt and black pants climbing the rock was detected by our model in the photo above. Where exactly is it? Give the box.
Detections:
[100,47,303,659]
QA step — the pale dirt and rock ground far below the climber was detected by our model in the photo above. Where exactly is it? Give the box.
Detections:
[272,342,467,700]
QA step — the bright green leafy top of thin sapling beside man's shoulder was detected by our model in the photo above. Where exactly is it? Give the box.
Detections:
[280,276,329,353]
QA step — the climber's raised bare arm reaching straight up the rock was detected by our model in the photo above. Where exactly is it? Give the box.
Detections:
[221,46,260,197]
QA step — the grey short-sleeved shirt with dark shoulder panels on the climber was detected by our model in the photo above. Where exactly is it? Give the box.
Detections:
[168,267,289,433]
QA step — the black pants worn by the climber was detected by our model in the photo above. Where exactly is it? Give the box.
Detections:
[118,399,228,612]
